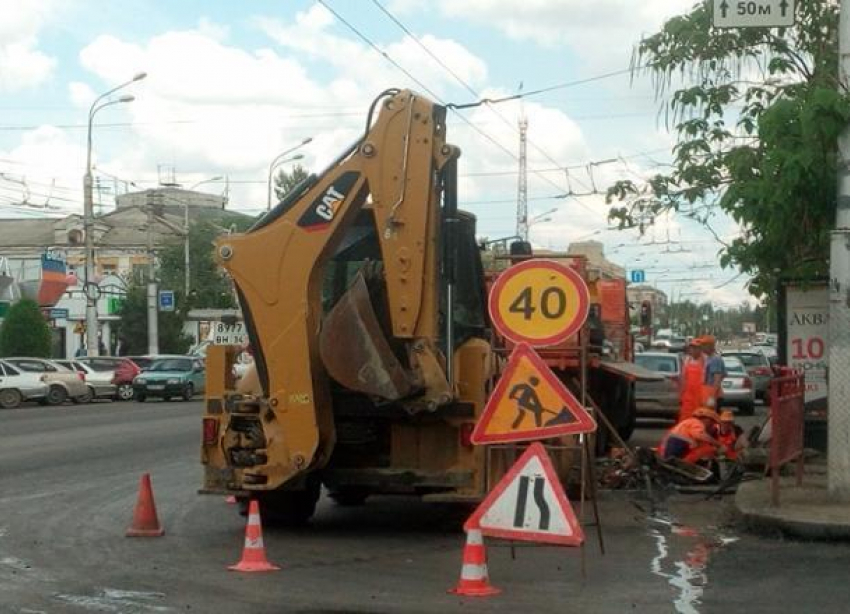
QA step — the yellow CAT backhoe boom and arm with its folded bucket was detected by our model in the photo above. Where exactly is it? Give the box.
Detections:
[211,90,459,490]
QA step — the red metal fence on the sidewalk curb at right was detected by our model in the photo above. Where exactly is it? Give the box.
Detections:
[769,368,806,507]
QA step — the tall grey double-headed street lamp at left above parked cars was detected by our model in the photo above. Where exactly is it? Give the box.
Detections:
[83,72,147,356]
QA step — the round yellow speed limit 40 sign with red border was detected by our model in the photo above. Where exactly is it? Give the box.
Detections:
[489,260,590,347]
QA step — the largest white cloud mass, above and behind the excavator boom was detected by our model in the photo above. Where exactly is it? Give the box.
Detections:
[61,7,588,215]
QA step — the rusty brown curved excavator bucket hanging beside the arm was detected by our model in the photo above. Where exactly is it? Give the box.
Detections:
[319,275,414,401]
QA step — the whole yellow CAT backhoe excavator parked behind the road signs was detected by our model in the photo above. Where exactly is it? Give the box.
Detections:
[201,89,568,523]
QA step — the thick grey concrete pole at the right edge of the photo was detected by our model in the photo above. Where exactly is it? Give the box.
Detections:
[827,0,850,501]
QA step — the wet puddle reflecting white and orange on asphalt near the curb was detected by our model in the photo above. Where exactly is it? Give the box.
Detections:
[646,512,738,614]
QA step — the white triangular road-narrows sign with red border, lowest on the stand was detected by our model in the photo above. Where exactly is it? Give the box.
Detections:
[464,442,584,546]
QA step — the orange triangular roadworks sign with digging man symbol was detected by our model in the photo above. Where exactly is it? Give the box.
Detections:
[472,343,596,444]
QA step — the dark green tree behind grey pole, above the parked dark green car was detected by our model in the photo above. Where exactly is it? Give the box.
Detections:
[117,279,192,356]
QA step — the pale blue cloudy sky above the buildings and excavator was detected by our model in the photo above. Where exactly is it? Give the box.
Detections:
[0,0,748,306]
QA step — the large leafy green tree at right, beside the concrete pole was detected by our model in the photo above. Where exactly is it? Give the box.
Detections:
[608,0,850,296]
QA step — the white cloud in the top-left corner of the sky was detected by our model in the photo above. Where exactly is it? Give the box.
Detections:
[0,0,56,92]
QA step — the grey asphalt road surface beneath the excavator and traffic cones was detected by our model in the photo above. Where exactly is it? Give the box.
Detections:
[0,402,850,614]
